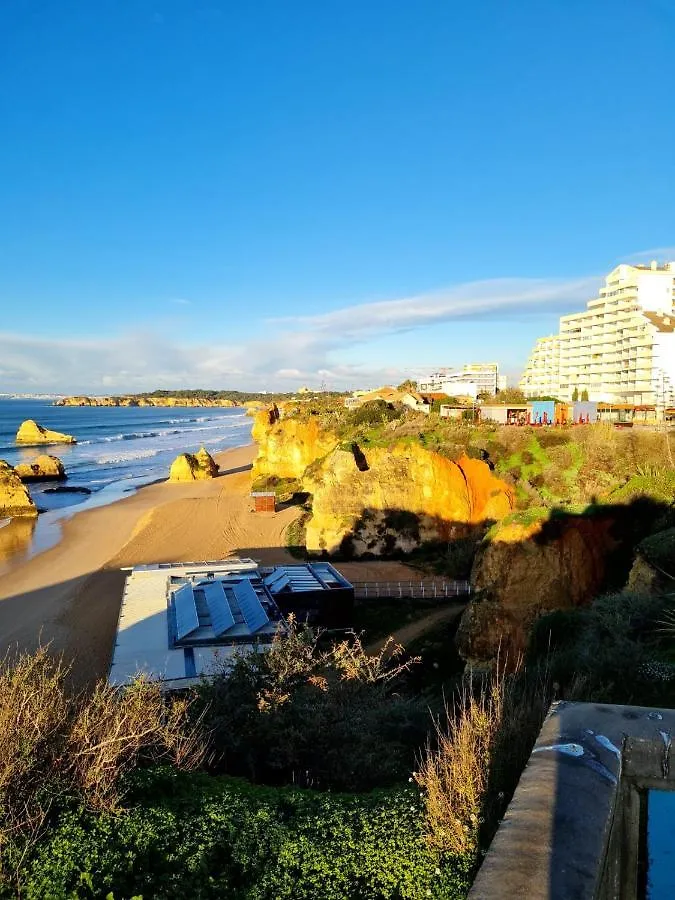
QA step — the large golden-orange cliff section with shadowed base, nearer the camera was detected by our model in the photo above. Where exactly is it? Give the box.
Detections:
[303,444,514,556]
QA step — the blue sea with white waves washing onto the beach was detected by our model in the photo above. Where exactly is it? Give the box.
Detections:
[0,398,251,561]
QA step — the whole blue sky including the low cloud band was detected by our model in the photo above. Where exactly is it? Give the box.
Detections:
[0,0,675,392]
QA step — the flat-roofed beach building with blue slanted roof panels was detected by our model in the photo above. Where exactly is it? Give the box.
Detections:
[108,557,354,690]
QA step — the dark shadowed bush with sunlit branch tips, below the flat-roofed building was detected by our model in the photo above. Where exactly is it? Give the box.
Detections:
[195,628,429,790]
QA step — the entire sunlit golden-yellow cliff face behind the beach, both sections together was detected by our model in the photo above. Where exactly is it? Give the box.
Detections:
[253,409,514,556]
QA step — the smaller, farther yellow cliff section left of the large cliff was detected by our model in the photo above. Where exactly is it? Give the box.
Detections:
[252,406,338,479]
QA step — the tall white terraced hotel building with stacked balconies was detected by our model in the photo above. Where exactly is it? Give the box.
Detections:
[520,262,675,406]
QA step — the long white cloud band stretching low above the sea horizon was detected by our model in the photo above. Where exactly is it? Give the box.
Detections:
[0,268,612,393]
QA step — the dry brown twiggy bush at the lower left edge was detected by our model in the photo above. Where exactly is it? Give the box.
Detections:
[0,648,205,884]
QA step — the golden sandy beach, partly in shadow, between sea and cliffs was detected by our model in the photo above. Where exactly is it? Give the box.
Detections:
[0,445,414,685]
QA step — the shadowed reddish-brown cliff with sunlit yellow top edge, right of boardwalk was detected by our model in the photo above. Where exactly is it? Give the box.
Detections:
[457,514,617,664]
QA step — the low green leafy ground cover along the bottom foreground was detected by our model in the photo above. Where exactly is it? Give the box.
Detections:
[11,770,473,900]
